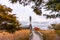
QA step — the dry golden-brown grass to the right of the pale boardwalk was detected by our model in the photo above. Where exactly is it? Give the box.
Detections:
[38,30,60,40]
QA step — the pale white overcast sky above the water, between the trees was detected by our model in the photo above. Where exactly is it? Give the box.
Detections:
[0,0,58,22]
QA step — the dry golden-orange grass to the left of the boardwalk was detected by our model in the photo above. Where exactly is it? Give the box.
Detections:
[0,29,30,40]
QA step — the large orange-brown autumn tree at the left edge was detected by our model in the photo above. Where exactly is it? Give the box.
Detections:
[0,4,20,32]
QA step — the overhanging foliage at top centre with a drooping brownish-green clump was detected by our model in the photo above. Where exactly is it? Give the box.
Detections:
[9,0,43,15]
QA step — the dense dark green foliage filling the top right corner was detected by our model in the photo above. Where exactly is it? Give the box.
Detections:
[45,0,60,12]
